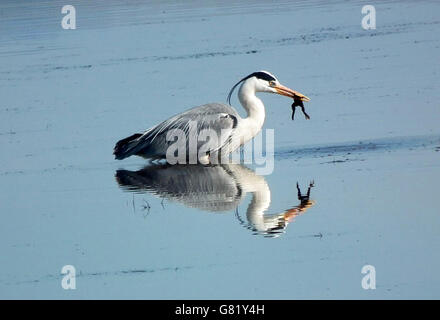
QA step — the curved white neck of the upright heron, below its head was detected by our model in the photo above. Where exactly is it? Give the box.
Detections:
[238,82,265,129]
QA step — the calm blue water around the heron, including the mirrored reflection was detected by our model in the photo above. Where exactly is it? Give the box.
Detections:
[0,1,440,299]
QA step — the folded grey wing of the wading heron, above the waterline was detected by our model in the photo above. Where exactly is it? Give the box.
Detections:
[124,103,240,158]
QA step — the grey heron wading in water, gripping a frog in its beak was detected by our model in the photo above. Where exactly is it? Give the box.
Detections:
[113,71,310,164]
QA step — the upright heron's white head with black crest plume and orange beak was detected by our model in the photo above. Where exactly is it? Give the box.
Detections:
[228,70,310,103]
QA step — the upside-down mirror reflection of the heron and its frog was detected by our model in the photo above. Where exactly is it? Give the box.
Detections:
[116,164,315,237]
